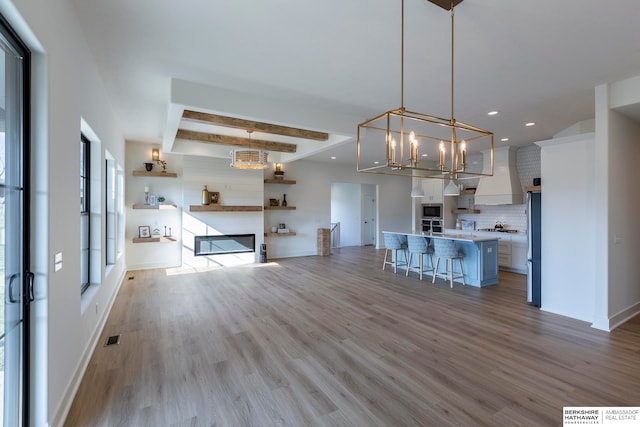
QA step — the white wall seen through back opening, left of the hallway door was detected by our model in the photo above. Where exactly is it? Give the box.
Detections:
[331,182,362,246]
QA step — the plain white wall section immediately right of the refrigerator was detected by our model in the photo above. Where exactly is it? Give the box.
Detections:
[537,134,606,322]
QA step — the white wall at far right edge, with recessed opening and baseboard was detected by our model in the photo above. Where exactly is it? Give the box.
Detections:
[593,76,640,330]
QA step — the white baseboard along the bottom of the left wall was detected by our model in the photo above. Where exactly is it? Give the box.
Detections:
[49,270,127,427]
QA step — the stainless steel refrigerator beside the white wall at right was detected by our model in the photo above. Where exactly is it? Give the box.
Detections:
[527,191,542,307]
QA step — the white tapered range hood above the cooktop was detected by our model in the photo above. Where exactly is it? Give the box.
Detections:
[475,147,524,205]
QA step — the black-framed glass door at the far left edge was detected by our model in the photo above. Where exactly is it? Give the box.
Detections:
[0,20,32,426]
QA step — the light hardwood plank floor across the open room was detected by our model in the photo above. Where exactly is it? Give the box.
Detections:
[65,247,640,427]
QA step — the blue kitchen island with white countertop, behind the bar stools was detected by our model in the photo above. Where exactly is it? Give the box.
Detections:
[383,230,498,287]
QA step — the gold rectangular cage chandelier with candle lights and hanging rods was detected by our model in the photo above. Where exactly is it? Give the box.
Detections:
[357,0,493,180]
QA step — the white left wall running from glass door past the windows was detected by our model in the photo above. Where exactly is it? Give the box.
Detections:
[0,0,125,425]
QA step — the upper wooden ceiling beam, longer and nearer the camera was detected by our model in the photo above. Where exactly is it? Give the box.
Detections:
[182,110,329,141]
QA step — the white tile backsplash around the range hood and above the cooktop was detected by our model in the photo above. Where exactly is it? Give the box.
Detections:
[458,144,540,232]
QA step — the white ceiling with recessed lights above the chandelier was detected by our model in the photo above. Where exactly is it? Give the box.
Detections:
[73,0,640,162]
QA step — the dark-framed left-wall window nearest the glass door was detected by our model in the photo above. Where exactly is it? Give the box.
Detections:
[80,134,91,293]
